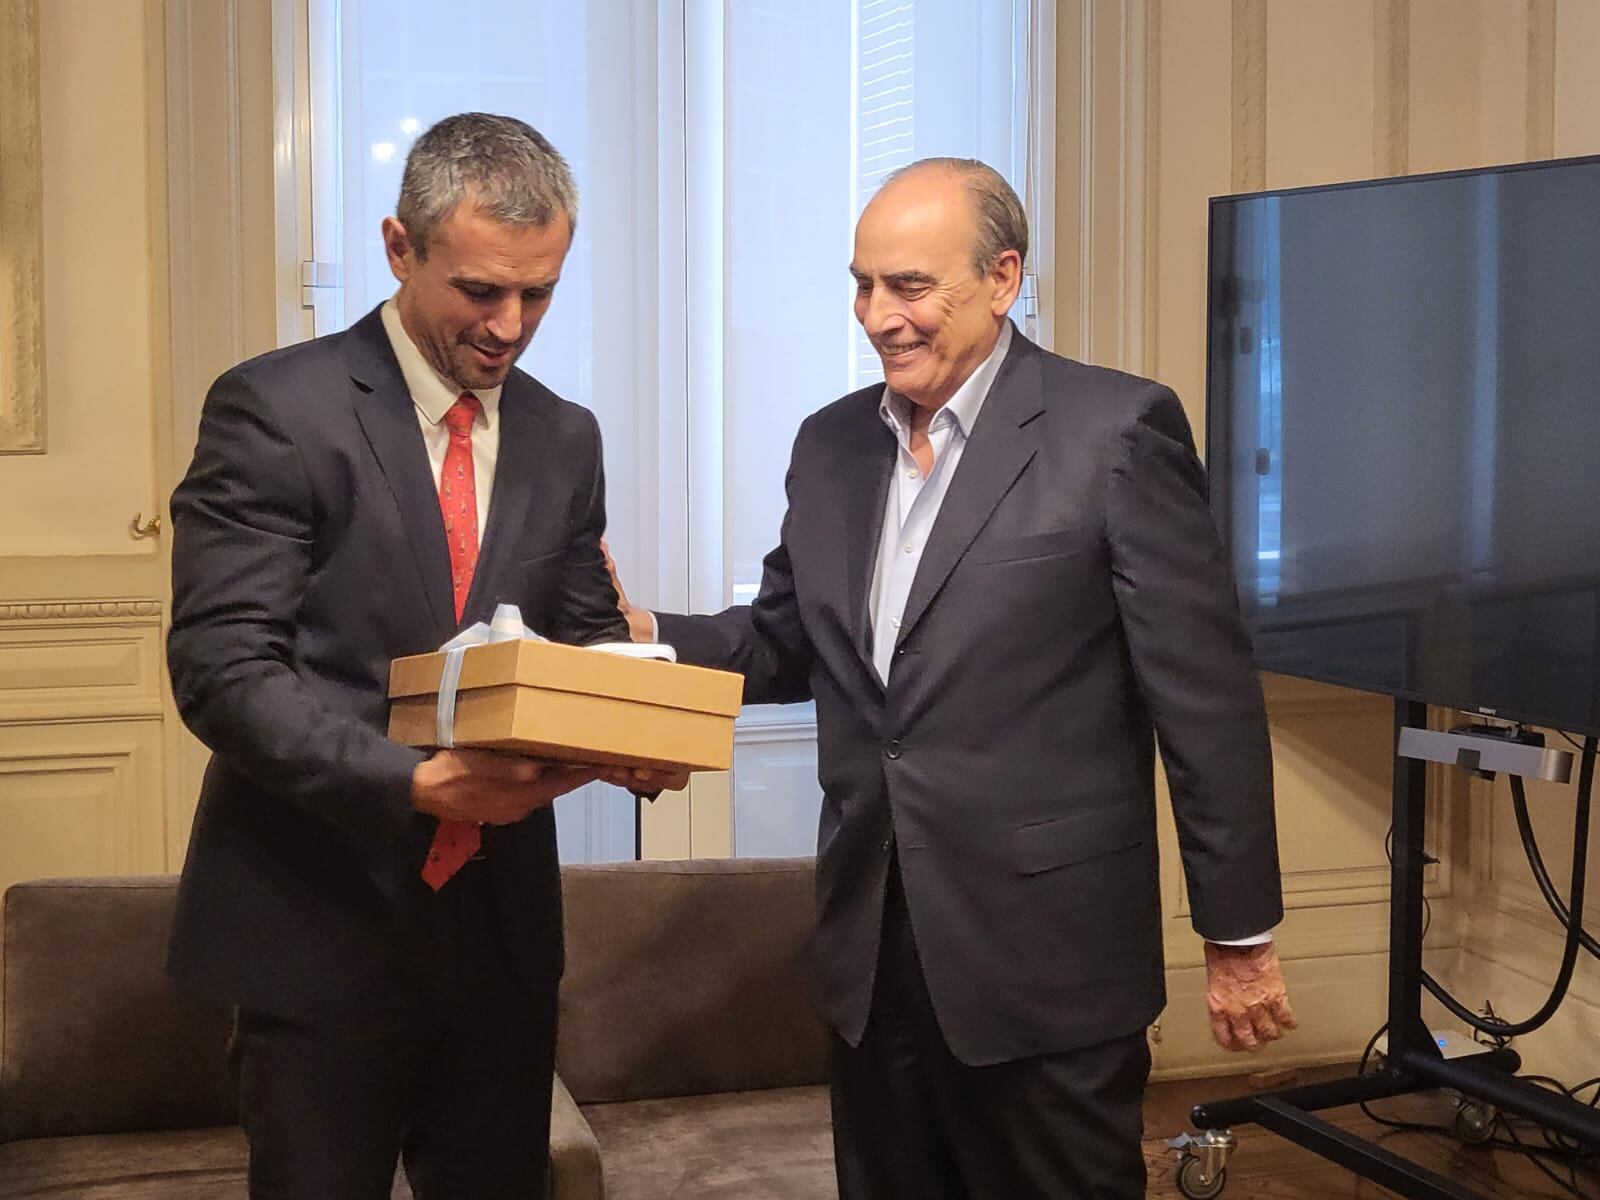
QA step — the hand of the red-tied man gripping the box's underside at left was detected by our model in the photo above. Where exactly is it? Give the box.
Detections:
[411,750,600,826]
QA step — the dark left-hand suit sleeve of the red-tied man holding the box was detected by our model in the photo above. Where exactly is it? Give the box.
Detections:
[166,371,426,835]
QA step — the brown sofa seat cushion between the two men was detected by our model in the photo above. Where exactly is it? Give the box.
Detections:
[584,1086,838,1200]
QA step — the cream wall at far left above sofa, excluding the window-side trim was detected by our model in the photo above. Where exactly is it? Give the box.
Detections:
[0,0,187,886]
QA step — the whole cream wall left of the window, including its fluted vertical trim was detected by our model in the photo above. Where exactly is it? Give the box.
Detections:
[0,0,282,888]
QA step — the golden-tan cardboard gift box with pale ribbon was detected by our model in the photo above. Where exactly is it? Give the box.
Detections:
[389,640,744,771]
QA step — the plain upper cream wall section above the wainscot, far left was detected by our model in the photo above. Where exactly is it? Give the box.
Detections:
[0,0,162,562]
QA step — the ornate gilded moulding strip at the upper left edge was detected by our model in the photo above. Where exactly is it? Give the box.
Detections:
[0,0,45,454]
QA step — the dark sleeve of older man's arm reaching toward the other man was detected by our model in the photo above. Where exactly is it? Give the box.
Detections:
[656,438,813,704]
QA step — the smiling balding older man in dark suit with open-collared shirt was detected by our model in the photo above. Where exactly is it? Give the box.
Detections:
[604,160,1293,1200]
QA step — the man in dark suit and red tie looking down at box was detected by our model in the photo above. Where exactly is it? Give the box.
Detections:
[168,114,677,1200]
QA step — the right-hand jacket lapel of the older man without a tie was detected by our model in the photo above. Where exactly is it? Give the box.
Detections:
[899,333,1045,642]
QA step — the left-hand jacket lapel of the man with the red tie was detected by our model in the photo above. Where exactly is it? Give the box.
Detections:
[344,309,456,643]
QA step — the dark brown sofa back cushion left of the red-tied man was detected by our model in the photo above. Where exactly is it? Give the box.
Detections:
[0,877,237,1142]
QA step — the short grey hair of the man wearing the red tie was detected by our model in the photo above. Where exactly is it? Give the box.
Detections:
[395,112,578,259]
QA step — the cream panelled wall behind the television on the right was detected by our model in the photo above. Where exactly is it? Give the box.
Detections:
[1053,0,1600,1075]
